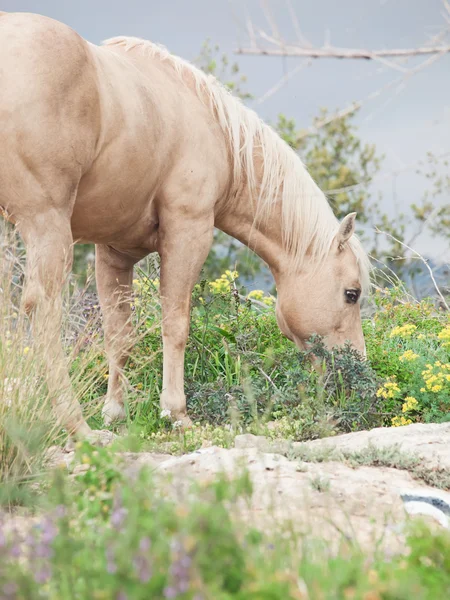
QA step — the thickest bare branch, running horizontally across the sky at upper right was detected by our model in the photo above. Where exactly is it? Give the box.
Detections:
[236,44,450,60]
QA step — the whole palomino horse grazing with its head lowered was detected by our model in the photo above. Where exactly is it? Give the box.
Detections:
[0,13,369,435]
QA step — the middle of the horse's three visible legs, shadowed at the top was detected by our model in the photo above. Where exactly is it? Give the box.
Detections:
[95,245,136,425]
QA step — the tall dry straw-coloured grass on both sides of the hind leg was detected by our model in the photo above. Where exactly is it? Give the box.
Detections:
[0,227,110,505]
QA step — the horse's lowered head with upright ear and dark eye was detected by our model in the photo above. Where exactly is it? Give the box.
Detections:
[276,213,365,354]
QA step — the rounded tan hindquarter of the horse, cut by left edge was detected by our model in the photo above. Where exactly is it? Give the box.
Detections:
[0,13,98,222]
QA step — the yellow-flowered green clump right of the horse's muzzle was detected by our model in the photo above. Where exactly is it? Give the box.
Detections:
[364,288,450,425]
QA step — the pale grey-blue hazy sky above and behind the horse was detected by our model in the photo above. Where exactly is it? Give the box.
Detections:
[0,0,450,257]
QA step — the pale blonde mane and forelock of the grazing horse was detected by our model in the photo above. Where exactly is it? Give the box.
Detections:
[103,37,370,291]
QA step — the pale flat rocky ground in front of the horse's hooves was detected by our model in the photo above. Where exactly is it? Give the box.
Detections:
[42,423,450,553]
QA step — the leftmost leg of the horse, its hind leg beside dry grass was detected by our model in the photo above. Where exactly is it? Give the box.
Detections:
[19,209,91,436]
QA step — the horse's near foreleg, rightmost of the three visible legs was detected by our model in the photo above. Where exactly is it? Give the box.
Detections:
[159,216,214,424]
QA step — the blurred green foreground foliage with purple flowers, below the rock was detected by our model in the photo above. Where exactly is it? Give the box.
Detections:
[0,446,450,600]
